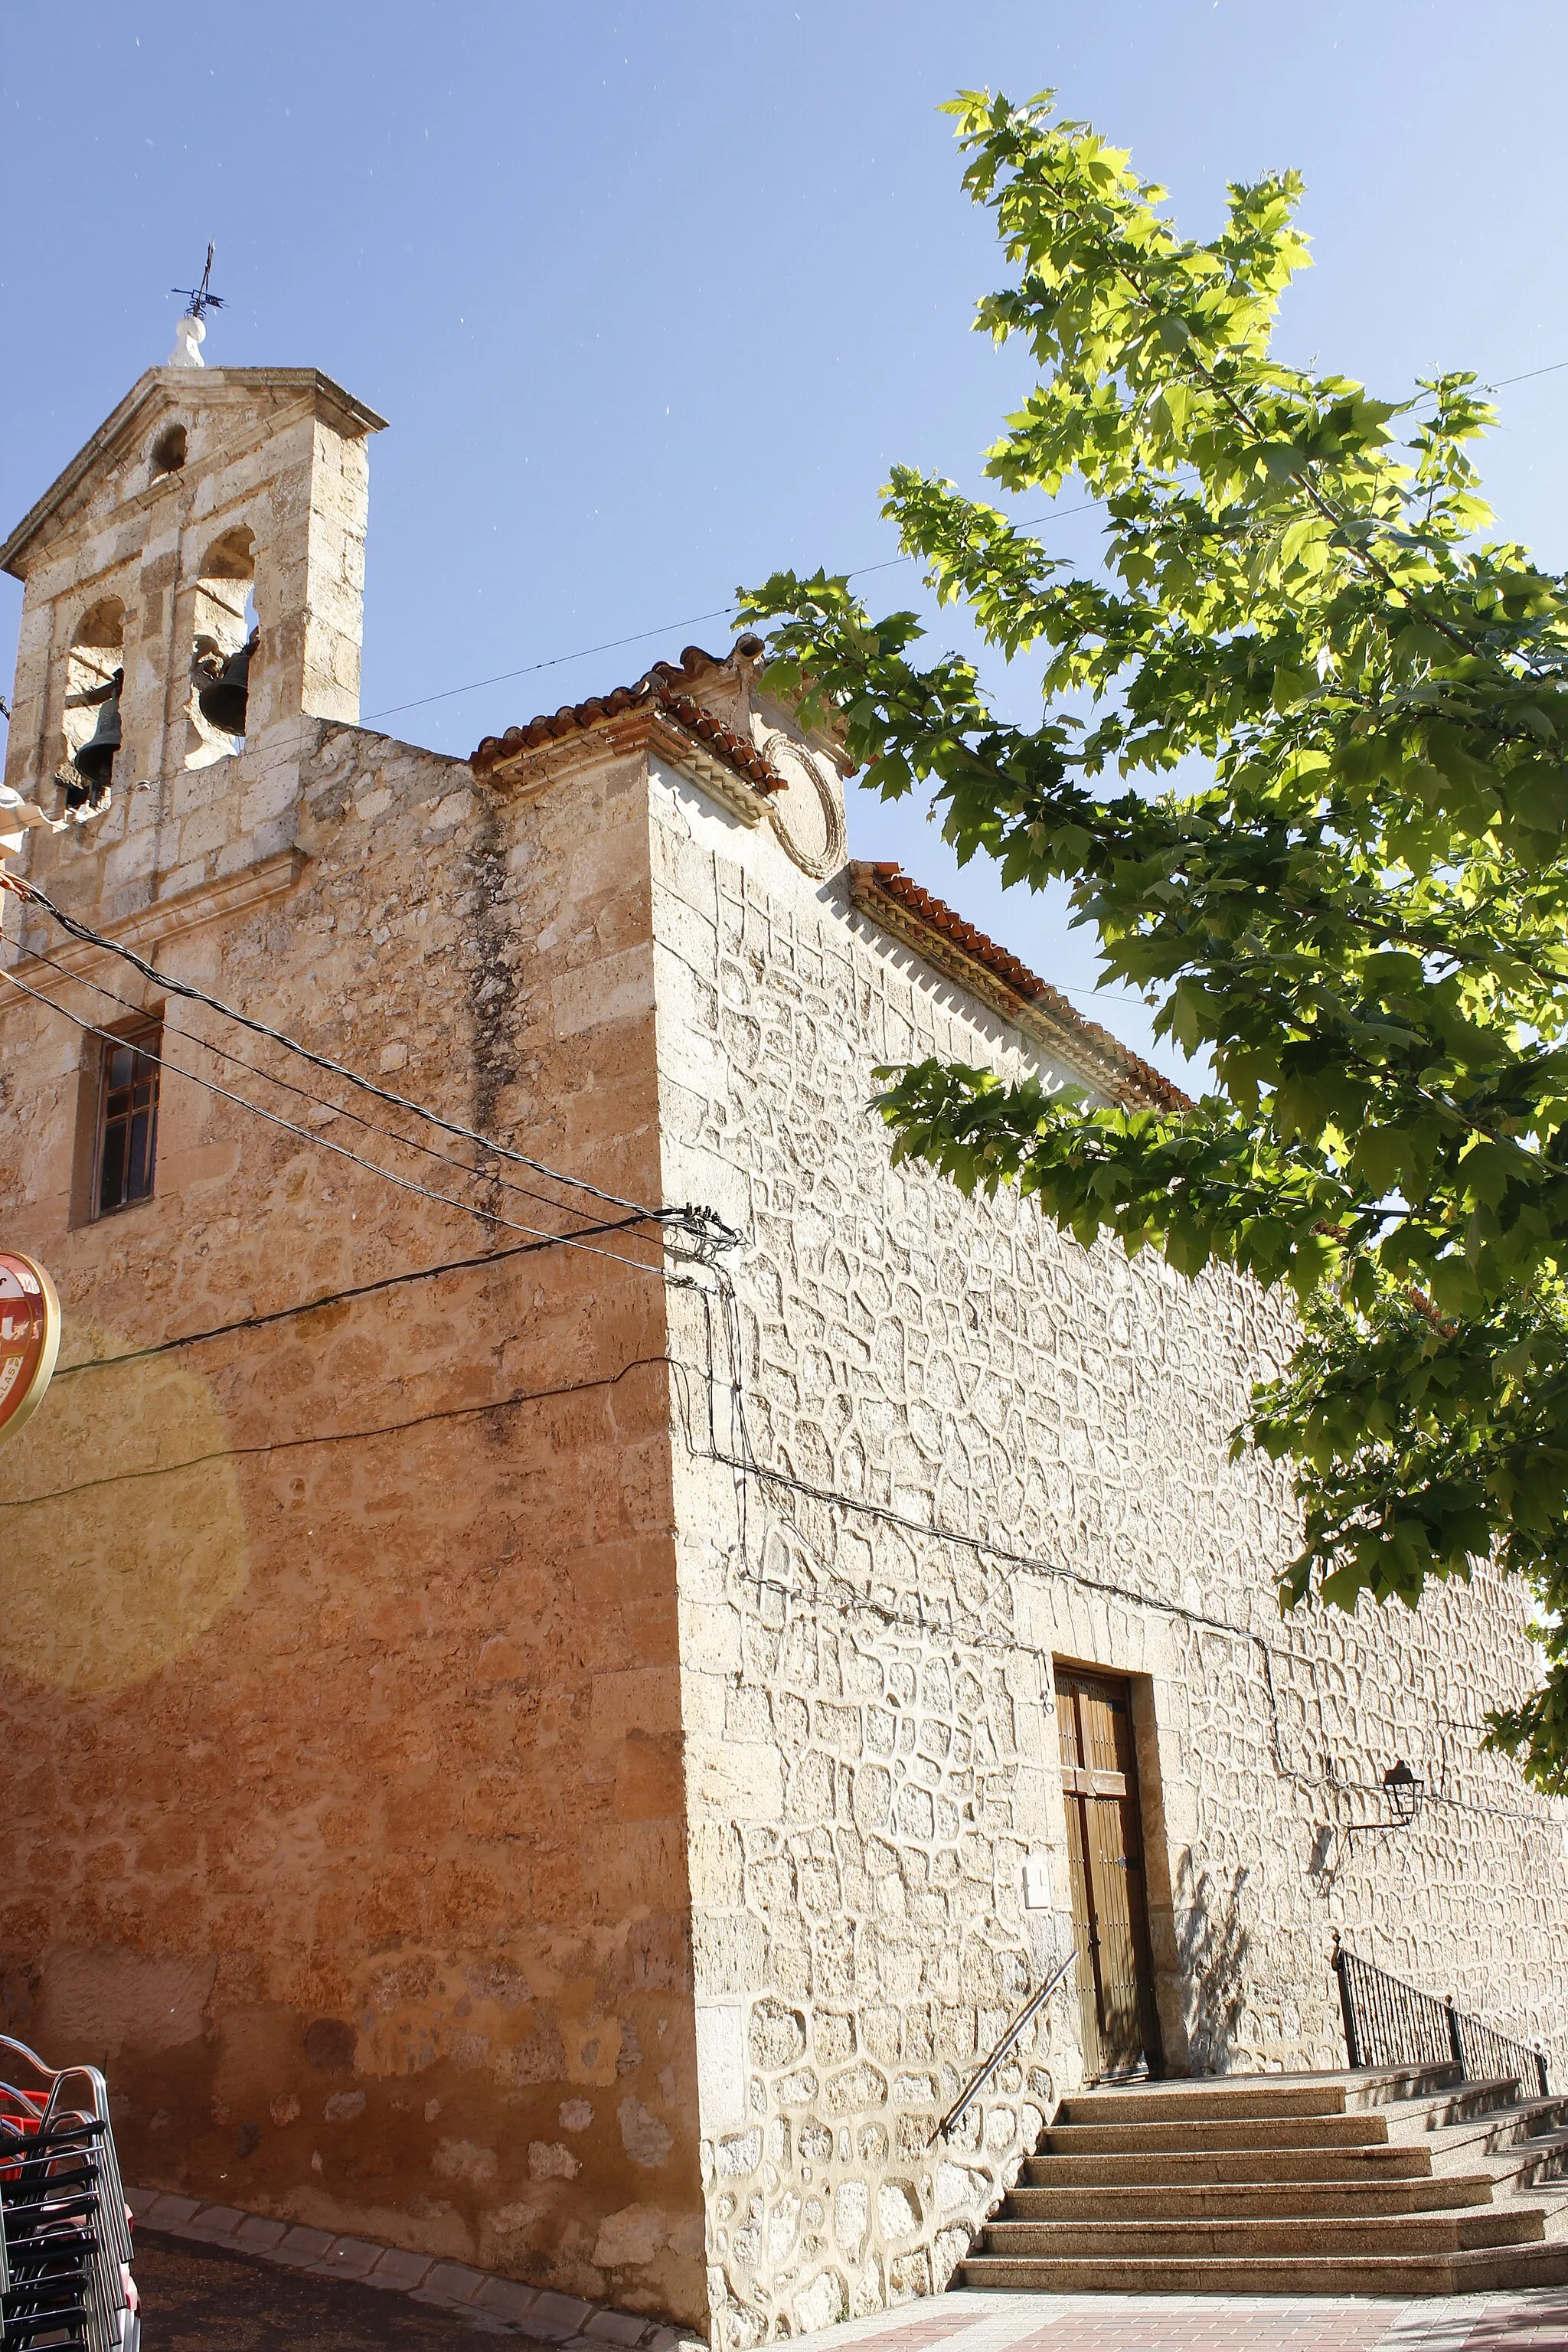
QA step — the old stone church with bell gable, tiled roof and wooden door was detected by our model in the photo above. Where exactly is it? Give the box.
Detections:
[0,338,1568,2347]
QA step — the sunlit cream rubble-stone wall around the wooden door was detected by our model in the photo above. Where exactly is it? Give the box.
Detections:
[654,757,1568,2345]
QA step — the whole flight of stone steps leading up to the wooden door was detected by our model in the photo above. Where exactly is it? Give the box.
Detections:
[962,2067,1568,2295]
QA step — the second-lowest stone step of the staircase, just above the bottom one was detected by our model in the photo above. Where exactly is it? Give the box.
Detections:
[980,2203,1547,2262]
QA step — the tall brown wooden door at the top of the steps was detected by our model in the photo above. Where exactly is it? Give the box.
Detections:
[1056,1668,1159,2079]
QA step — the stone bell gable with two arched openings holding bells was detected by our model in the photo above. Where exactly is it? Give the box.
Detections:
[0,341,383,920]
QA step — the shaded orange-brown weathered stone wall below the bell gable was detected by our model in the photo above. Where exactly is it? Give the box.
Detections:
[0,727,705,2319]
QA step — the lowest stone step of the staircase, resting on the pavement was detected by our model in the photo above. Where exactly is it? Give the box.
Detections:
[959,2246,1568,2298]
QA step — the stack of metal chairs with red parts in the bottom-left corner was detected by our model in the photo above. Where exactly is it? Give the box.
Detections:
[0,2034,141,2352]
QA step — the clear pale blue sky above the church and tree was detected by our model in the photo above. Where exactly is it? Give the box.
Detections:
[0,0,1568,1070]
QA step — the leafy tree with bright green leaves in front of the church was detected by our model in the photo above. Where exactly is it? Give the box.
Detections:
[745,94,1568,1790]
